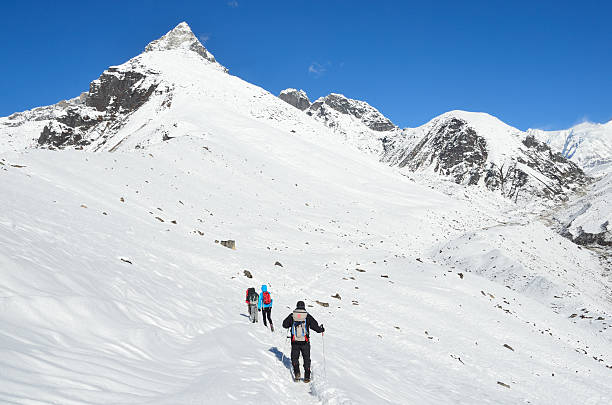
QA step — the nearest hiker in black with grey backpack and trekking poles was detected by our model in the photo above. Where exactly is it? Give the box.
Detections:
[283,301,325,382]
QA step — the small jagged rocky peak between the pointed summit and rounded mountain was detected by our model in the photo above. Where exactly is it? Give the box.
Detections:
[306,93,396,132]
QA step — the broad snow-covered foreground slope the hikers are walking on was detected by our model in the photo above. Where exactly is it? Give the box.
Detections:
[0,135,612,404]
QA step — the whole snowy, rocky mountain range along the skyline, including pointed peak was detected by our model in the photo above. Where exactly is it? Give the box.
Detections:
[0,23,612,246]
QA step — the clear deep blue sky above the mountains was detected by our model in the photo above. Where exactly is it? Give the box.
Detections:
[0,0,612,129]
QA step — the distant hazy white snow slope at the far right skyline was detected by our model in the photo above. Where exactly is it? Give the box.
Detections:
[527,121,612,176]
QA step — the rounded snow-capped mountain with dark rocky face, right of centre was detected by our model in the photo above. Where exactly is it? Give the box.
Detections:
[382,112,590,201]
